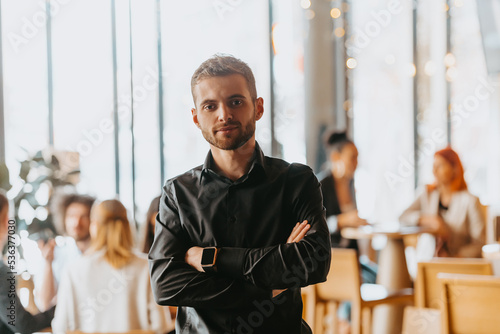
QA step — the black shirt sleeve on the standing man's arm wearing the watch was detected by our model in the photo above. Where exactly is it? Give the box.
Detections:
[217,165,331,289]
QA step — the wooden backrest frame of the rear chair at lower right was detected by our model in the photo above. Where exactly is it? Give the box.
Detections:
[415,258,493,309]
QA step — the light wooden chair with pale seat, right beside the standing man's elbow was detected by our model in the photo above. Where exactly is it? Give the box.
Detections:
[314,249,414,334]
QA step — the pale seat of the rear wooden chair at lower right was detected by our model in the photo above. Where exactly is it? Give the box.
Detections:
[402,306,441,334]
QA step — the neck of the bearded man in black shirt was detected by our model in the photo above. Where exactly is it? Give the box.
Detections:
[210,138,255,181]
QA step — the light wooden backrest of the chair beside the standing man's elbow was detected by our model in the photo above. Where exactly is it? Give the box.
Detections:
[316,248,361,301]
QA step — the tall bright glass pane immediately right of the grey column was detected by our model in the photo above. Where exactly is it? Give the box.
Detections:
[347,1,415,224]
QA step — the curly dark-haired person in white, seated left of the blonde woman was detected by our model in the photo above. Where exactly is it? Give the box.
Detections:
[36,194,95,309]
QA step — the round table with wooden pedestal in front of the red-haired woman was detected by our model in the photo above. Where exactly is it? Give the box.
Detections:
[341,225,430,334]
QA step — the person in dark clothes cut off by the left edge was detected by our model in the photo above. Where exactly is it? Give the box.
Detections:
[0,193,54,334]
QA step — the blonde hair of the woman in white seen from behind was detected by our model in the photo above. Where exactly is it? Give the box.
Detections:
[90,199,134,268]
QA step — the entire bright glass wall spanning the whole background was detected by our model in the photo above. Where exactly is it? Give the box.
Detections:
[1,0,500,234]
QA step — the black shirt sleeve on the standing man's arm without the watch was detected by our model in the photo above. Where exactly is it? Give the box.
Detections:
[149,182,271,309]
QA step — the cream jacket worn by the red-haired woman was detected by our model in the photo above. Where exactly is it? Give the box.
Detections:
[399,190,486,257]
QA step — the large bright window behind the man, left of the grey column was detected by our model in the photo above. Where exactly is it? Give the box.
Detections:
[1,0,290,226]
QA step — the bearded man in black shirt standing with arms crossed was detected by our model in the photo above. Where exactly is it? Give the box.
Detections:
[149,55,331,334]
